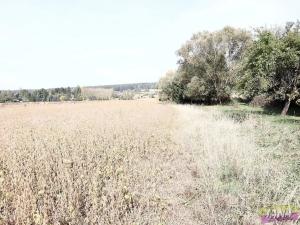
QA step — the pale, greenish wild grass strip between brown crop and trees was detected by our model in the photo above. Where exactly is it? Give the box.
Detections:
[178,106,300,224]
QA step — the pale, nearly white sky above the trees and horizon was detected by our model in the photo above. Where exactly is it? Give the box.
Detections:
[0,0,300,89]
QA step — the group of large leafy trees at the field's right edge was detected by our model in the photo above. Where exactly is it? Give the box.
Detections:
[158,21,300,115]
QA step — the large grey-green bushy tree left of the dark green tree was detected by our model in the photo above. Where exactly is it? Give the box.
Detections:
[178,27,251,103]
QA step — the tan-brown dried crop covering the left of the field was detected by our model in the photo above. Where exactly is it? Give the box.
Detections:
[0,101,182,225]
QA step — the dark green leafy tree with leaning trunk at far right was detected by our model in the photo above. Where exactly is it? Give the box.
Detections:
[240,22,300,115]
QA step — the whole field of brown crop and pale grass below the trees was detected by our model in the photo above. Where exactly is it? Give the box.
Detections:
[0,99,300,225]
